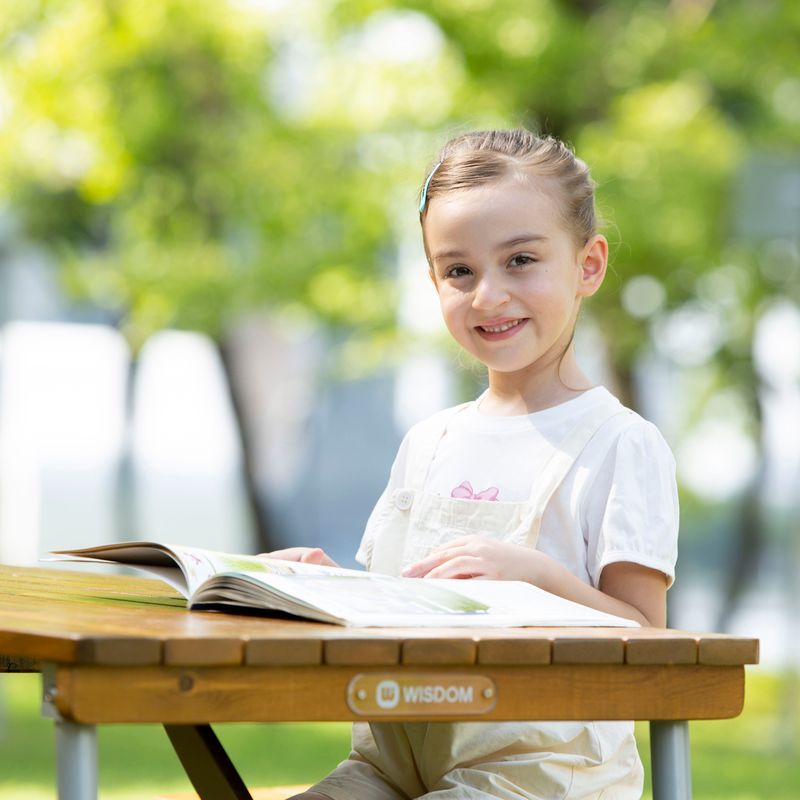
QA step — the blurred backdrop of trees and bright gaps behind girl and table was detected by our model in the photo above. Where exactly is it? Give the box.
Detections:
[0,0,800,798]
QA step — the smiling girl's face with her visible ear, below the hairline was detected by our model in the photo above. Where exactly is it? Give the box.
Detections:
[424,176,607,378]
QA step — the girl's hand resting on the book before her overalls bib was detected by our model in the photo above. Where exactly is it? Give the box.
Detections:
[403,536,547,583]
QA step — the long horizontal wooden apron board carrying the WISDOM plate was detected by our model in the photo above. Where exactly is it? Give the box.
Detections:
[55,664,744,724]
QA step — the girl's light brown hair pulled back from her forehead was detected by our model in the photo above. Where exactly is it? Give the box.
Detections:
[419,128,598,246]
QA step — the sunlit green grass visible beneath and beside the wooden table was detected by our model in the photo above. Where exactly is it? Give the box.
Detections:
[0,670,800,800]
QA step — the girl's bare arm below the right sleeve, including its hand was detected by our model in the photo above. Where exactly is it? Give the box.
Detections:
[403,536,667,627]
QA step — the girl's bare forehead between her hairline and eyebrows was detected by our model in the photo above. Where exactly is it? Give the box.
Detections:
[423,175,568,250]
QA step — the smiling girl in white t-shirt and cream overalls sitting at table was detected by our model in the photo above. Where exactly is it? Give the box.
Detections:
[272,130,678,800]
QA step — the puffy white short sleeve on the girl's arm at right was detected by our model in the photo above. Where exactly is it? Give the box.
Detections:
[585,416,679,586]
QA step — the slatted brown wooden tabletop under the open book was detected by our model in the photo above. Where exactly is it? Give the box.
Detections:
[0,566,758,670]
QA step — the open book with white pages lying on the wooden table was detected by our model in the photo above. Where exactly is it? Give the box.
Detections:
[52,542,638,628]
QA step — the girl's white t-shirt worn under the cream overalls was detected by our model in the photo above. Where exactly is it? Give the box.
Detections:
[356,387,678,586]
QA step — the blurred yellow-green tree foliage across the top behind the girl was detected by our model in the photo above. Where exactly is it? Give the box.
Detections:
[0,0,800,600]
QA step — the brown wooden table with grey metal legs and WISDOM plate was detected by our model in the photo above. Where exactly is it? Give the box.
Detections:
[0,566,758,800]
